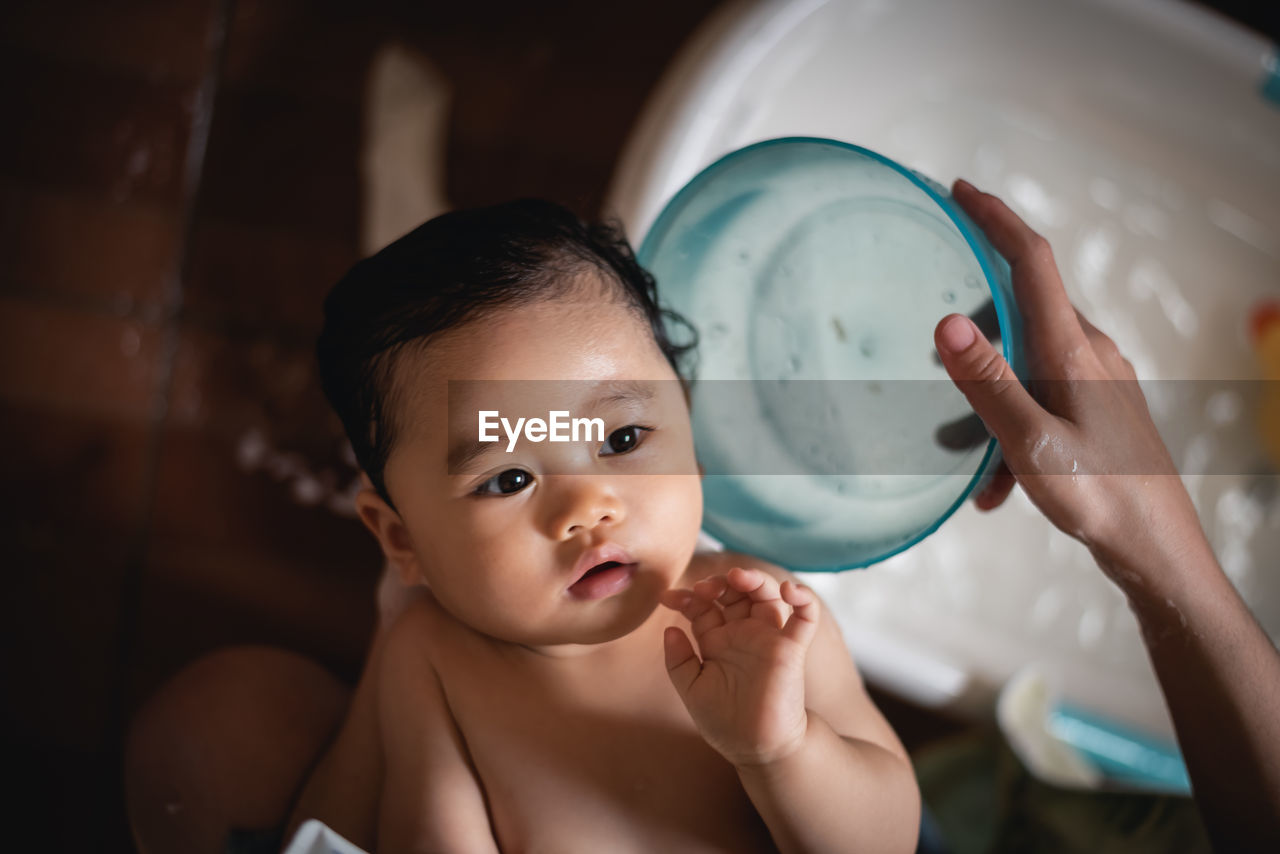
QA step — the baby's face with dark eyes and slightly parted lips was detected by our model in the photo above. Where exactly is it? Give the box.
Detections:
[385,287,701,647]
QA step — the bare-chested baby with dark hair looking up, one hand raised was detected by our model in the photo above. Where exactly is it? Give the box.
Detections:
[293,201,920,854]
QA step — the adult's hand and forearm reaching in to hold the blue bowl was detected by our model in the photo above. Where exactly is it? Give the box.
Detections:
[936,182,1280,851]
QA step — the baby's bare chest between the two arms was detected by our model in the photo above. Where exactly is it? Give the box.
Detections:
[442,653,774,853]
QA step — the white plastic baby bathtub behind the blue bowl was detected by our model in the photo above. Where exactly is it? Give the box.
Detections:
[609,0,1280,768]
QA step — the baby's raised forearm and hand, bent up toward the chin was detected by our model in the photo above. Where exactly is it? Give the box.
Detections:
[664,561,920,851]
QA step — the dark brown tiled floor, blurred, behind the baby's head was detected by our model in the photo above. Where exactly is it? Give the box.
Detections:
[0,0,1277,851]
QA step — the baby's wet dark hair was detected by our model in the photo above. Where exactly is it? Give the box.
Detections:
[316,198,696,507]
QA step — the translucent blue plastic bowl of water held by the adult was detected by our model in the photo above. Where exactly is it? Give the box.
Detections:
[639,137,1023,571]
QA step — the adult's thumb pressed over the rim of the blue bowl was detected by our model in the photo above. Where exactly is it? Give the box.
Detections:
[933,314,1044,448]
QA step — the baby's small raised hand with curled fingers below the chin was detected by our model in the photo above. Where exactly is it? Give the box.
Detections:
[662,567,819,766]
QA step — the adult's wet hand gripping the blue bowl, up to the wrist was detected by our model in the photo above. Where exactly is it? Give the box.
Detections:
[934,181,1203,575]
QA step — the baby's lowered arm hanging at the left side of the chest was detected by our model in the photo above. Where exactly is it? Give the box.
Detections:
[378,602,498,854]
